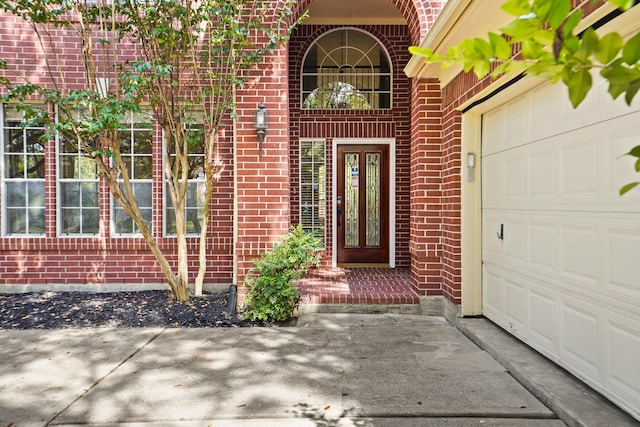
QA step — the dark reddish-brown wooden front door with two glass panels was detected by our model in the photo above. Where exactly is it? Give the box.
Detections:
[335,145,389,264]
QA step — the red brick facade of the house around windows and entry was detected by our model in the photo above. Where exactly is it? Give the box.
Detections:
[0,0,480,304]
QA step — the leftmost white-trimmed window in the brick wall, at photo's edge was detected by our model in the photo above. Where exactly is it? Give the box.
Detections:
[2,104,45,236]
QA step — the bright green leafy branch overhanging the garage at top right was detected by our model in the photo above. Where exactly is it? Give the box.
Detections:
[409,0,640,195]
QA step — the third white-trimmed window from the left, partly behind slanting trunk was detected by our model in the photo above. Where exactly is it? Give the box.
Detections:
[111,110,153,236]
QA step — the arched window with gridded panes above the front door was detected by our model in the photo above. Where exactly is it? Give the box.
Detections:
[302,28,392,110]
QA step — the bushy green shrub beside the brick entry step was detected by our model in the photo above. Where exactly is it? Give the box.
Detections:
[242,225,321,322]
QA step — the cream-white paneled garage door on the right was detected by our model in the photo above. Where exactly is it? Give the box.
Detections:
[482,75,640,419]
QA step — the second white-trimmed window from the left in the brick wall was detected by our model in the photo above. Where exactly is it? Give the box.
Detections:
[58,123,100,236]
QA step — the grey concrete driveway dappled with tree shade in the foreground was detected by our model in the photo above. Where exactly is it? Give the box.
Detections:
[0,314,637,427]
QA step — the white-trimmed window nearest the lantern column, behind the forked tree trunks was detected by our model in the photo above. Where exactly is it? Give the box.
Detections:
[164,120,206,236]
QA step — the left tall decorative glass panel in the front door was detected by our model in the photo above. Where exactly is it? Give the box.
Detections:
[344,153,360,247]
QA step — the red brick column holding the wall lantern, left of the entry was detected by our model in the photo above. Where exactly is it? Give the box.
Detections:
[234,44,290,301]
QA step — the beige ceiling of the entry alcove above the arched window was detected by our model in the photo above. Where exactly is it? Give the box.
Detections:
[303,0,407,25]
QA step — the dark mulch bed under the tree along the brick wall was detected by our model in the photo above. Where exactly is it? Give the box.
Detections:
[0,290,256,329]
